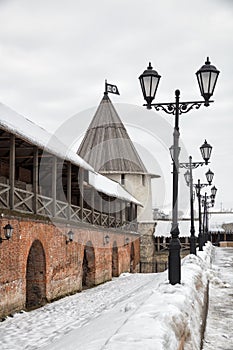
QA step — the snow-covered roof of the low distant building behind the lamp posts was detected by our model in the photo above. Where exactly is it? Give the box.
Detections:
[154,220,199,237]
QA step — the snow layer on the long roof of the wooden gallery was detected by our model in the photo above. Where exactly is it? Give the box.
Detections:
[0,103,141,205]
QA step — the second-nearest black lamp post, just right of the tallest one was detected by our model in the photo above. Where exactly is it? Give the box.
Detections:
[180,140,212,255]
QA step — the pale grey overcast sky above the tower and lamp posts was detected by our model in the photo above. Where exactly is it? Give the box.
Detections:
[0,0,233,212]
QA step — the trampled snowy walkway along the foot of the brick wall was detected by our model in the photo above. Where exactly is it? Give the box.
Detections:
[0,272,167,350]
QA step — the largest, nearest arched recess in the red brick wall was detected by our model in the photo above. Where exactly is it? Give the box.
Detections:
[26,239,46,309]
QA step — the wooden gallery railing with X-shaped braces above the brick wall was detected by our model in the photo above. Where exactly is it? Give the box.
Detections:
[0,182,137,232]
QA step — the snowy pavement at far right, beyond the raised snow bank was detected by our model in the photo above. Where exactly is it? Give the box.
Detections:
[203,248,233,350]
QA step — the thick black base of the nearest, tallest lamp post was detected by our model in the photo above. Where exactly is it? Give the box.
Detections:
[168,237,181,285]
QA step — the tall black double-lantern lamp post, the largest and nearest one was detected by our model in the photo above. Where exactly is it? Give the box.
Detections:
[139,58,219,285]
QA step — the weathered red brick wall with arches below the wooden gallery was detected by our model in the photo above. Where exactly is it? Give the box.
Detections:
[0,217,140,317]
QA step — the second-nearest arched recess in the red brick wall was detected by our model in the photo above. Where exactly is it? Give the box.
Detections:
[82,241,96,289]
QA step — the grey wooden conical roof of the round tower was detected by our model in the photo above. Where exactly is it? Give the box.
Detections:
[77,93,148,174]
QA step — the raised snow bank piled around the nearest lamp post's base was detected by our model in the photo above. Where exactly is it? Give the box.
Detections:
[100,244,213,350]
